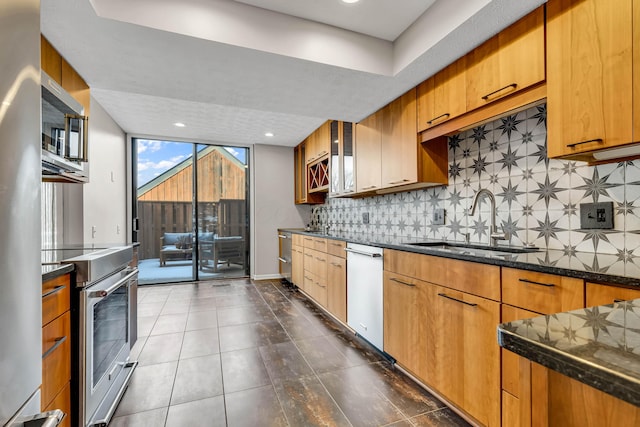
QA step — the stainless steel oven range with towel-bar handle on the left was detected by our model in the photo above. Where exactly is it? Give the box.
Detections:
[54,246,138,427]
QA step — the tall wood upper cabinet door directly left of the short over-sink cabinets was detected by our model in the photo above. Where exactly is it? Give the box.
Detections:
[381,89,418,188]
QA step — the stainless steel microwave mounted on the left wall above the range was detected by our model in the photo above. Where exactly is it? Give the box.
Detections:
[41,71,89,183]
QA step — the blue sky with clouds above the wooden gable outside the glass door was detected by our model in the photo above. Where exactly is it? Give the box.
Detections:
[136,139,248,187]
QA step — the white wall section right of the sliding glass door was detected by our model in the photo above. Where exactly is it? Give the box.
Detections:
[250,145,310,280]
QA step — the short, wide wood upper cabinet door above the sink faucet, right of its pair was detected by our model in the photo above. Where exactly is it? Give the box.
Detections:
[465,7,545,111]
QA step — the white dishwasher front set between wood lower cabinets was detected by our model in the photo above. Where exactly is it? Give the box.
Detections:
[345,243,384,350]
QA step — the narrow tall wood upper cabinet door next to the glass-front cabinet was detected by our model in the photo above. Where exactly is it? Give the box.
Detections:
[355,110,383,193]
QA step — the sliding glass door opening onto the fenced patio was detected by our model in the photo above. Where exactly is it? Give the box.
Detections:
[133,138,249,284]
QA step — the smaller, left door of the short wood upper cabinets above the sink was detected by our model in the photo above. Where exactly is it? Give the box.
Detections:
[417,57,467,132]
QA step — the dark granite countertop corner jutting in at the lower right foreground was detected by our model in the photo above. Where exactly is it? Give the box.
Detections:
[498,299,640,406]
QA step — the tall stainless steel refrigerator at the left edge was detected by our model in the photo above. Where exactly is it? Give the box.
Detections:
[0,0,42,426]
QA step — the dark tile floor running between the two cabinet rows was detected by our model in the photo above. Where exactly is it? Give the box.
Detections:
[110,279,468,427]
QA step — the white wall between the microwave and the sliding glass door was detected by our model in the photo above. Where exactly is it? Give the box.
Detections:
[82,98,127,244]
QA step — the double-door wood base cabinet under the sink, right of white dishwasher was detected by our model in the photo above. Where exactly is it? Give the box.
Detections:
[384,250,501,426]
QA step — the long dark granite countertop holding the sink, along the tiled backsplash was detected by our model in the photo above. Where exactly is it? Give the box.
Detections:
[279,228,640,287]
